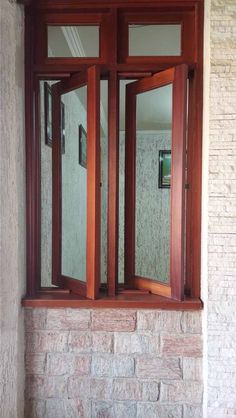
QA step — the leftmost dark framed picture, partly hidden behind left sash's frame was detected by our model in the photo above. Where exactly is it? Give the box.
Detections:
[44,82,66,154]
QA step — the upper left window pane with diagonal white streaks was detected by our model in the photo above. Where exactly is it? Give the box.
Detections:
[48,25,100,58]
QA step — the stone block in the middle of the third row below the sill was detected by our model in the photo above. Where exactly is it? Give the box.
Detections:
[92,355,134,377]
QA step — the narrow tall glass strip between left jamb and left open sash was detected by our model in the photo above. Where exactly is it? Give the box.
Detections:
[40,81,56,287]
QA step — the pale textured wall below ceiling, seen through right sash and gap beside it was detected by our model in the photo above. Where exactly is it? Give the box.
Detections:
[119,131,171,283]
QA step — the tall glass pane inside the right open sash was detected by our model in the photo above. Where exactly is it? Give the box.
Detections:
[135,85,172,283]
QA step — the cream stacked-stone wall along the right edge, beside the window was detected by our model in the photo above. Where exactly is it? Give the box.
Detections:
[207,0,236,418]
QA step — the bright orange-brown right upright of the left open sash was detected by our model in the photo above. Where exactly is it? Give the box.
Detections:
[87,66,101,299]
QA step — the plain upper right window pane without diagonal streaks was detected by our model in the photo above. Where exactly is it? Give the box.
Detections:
[129,24,181,56]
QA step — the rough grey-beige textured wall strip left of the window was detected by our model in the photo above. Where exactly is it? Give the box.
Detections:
[0,0,25,418]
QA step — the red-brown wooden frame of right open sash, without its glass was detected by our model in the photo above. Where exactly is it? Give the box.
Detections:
[125,64,188,300]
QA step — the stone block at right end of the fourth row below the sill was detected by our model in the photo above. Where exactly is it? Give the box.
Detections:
[160,381,203,405]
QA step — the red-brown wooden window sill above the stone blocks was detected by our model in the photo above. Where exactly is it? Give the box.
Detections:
[22,290,203,310]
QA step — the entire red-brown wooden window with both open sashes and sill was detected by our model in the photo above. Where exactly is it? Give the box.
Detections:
[22,0,204,309]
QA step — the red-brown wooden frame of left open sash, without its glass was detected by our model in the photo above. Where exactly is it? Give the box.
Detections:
[52,66,100,299]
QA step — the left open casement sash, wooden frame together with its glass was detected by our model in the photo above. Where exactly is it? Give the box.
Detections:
[52,66,100,299]
